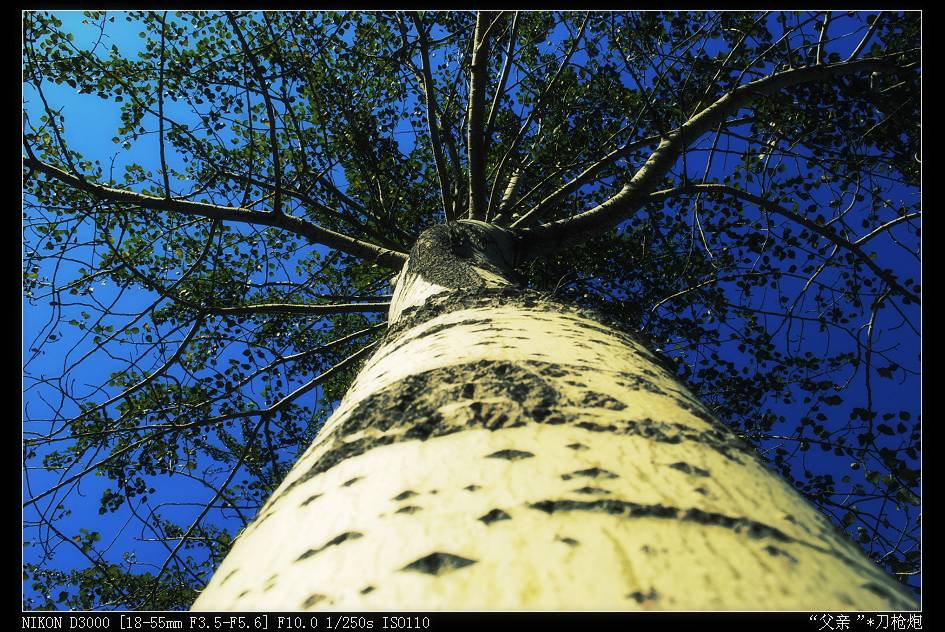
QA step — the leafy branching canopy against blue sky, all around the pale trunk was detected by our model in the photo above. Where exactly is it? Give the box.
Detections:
[23,11,921,609]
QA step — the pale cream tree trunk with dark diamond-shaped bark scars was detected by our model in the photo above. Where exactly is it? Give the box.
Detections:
[194,222,914,610]
